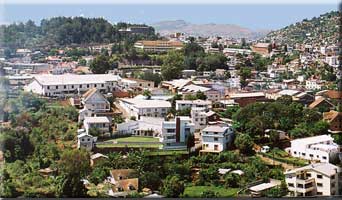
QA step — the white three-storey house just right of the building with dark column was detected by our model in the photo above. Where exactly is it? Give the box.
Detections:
[200,126,234,153]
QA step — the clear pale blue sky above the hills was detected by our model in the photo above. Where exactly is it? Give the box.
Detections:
[0,0,338,30]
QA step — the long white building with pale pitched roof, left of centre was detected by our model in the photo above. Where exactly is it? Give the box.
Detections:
[25,74,121,97]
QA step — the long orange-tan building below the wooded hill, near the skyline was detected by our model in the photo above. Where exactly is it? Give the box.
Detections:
[134,40,183,52]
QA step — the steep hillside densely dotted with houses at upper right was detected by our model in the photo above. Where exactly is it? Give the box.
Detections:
[264,11,339,45]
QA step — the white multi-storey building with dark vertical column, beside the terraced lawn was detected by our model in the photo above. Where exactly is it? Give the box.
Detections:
[159,116,195,149]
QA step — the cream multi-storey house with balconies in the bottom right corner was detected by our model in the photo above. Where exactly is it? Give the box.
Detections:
[284,163,342,197]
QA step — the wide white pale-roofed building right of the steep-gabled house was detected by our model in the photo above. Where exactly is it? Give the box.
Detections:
[119,98,171,119]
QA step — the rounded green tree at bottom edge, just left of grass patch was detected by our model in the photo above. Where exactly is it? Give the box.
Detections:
[162,175,184,198]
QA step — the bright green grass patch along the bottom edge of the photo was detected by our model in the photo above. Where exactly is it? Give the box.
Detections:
[184,186,239,198]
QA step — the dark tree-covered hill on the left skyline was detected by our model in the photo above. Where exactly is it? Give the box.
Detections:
[0,17,157,49]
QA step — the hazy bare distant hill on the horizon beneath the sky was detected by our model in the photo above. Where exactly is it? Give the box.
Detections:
[151,20,269,39]
